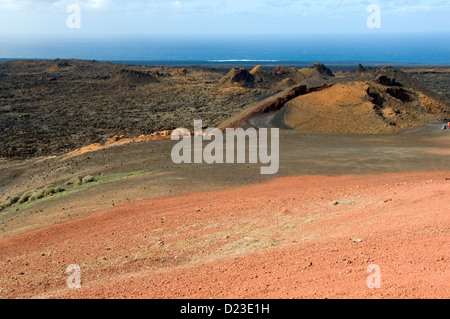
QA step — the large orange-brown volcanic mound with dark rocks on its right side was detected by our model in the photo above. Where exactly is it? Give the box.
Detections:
[284,79,450,134]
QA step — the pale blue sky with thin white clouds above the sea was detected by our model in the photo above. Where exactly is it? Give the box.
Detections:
[0,0,450,37]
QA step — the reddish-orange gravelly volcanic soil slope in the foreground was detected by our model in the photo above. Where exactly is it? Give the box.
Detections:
[0,172,450,298]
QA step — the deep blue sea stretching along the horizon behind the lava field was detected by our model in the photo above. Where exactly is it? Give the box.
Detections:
[0,33,450,64]
